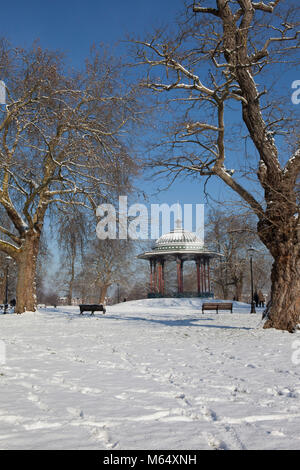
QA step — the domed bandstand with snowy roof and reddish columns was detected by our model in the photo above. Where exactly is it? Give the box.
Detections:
[138,223,222,297]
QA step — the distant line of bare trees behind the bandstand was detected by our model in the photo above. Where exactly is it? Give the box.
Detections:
[28,207,271,305]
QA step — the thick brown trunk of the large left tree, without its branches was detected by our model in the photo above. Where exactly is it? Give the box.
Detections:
[15,230,40,313]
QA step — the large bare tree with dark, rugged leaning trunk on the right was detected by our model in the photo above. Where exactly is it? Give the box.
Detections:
[135,0,300,332]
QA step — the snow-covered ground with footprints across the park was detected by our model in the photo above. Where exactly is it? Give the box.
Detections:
[0,299,300,450]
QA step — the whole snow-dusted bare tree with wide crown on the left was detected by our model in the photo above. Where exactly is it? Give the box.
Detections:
[0,41,135,313]
